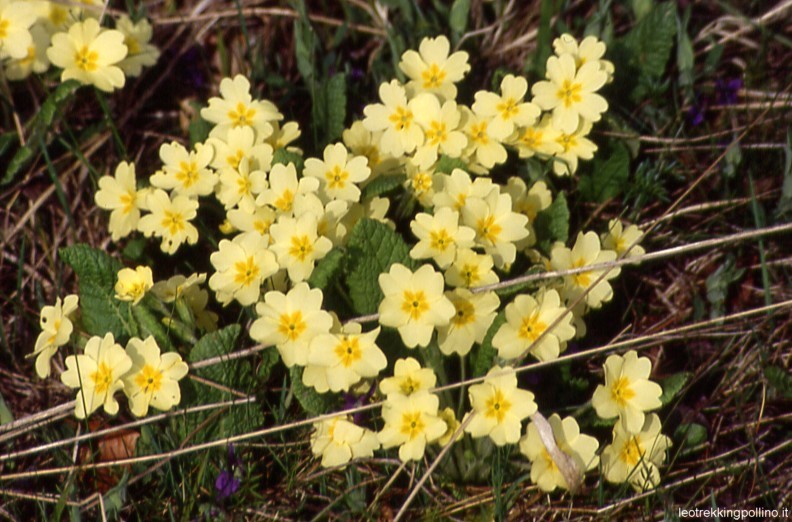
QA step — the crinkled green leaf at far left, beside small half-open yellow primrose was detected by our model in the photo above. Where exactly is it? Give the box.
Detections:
[59,244,132,339]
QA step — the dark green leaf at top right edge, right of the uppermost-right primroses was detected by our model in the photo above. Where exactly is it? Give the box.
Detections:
[623,2,677,78]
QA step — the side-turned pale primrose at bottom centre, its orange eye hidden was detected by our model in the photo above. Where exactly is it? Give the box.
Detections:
[311,417,380,468]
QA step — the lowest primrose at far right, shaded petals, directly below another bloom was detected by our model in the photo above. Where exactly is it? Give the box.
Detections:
[602,413,671,492]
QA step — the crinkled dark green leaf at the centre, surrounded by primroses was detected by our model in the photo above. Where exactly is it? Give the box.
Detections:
[346,218,415,314]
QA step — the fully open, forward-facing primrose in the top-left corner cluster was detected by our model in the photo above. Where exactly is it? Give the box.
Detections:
[47,18,127,92]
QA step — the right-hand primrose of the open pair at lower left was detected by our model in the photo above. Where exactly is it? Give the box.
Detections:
[123,336,187,417]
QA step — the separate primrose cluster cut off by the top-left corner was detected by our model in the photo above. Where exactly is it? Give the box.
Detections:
[0,0,160,88]
